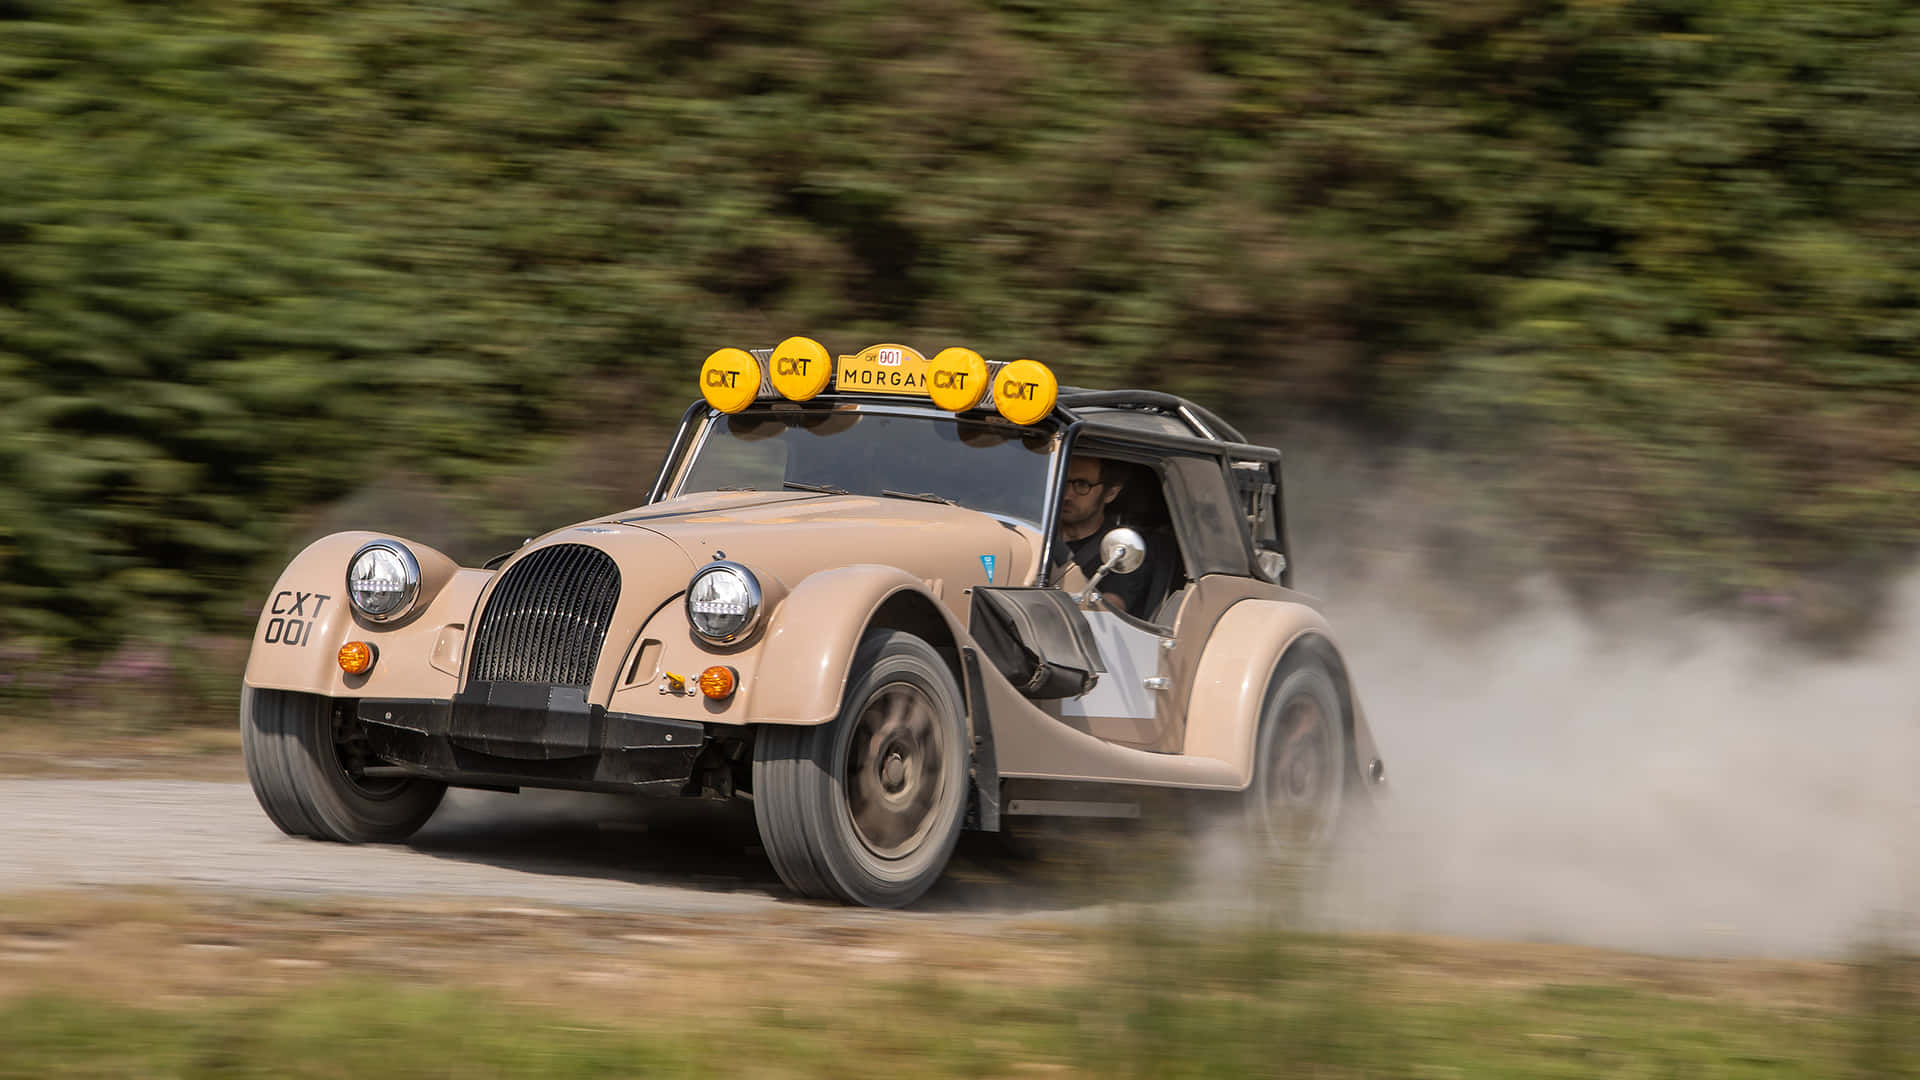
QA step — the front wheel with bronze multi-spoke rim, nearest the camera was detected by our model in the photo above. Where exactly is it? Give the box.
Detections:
[753,630,972,907]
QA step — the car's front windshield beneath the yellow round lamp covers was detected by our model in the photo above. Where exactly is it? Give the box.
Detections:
[680,409,1054,523]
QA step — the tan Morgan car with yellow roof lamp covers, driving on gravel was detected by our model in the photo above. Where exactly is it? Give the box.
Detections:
[240,338,1384,907]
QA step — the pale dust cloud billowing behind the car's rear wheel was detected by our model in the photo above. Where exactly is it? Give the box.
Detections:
[1311,575,1920,957]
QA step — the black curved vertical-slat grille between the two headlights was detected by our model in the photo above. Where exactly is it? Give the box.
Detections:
[467,544,620,688]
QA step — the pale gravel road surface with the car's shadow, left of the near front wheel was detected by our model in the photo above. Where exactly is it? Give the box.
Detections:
[0,780,840,915]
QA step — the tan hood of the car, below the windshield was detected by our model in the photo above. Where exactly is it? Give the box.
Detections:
[599,492,1035,595]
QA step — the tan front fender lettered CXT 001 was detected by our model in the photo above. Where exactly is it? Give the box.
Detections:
[244,532,493,698]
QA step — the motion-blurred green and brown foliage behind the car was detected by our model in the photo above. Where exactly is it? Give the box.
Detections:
[0,0,1920,687]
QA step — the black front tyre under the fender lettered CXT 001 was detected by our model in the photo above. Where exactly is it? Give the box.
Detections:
[240,688,447,844]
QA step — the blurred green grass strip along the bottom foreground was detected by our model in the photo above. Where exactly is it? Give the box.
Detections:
[0,899,1920,1078]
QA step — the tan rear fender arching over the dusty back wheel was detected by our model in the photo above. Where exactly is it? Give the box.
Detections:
[1185,600,1379,788]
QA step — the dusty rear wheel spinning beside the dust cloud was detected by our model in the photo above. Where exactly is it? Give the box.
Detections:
[1246,663,1348,861]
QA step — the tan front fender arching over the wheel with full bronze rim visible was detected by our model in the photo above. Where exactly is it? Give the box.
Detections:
[747,563,966,724]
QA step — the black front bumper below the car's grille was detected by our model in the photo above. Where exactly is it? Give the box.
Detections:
[355,682,707,792]
